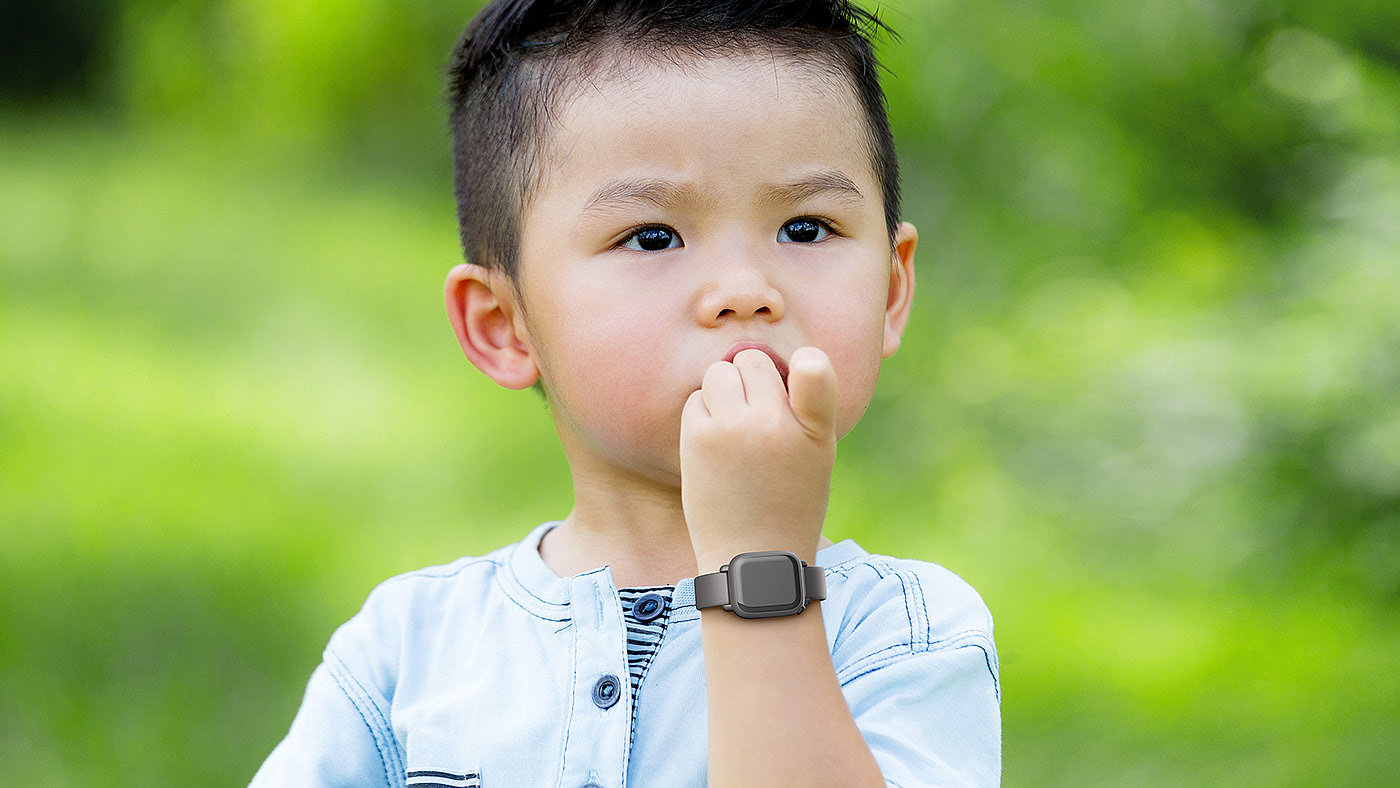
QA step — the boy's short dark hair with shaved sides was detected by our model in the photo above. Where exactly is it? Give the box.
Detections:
[447,0,899,393]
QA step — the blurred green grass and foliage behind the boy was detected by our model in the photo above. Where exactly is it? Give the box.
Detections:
[0,0,1400,785]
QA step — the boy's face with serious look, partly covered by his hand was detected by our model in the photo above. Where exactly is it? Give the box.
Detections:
[519,56,914,484]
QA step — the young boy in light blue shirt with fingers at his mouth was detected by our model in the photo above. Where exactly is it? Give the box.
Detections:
[253,0,1001,788]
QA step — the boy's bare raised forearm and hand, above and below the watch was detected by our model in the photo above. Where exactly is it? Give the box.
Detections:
[680,347,885,787]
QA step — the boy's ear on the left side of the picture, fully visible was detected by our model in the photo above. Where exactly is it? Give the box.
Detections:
[447,263,539,389]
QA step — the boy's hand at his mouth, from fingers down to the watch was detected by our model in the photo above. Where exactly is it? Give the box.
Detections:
[680,347,836,572]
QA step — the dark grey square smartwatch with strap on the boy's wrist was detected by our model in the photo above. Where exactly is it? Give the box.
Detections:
[694,550,826,619]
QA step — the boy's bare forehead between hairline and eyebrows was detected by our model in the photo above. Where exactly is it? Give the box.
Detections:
[538,53,878,207]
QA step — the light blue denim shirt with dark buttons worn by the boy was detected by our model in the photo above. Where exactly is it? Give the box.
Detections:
[252,521,1001,788]
